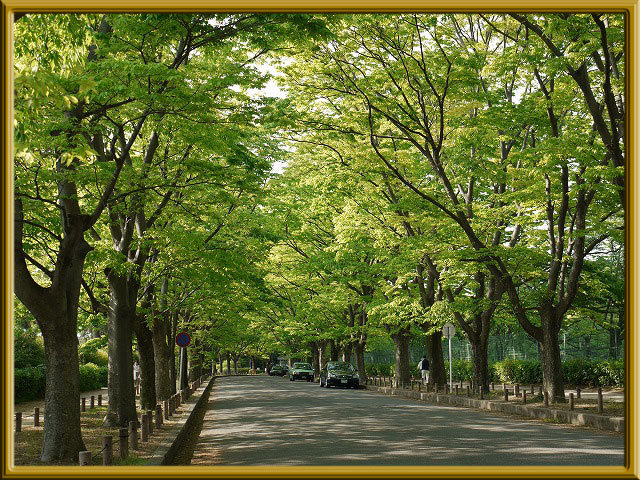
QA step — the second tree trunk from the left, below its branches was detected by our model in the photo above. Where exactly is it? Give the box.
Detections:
[104,272,138,427]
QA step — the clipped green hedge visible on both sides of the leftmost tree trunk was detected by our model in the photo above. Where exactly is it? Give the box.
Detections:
[13,363,108,402]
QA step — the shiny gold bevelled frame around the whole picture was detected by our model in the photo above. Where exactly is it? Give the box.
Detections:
[0,0,640,479]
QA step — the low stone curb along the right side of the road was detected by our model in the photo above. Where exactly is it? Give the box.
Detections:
[361,385,624,432]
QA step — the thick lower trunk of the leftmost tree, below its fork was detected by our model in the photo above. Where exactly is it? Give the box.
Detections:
[40,318,86,463]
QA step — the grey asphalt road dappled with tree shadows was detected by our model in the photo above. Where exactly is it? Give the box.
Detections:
[191,376,624,466]
